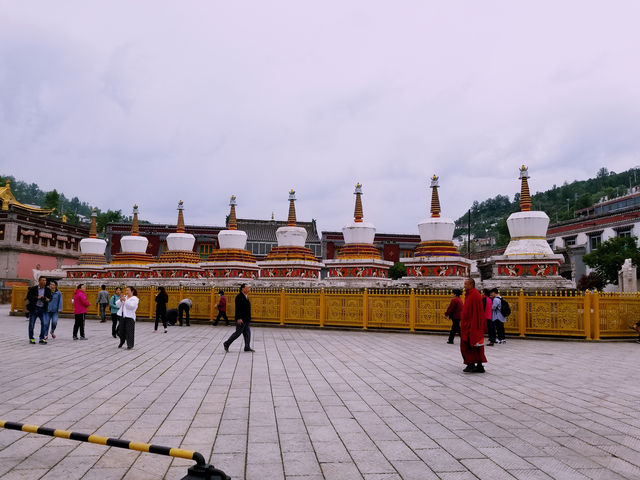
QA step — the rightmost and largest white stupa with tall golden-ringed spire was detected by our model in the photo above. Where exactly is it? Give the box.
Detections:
[483,165,575,290]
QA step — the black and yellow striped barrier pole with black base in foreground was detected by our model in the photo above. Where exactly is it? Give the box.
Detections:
[0,420,231,480]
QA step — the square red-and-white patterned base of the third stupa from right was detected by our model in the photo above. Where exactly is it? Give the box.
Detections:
[323,258,393,288]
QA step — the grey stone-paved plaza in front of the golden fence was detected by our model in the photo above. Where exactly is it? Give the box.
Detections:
[0,306,640,480]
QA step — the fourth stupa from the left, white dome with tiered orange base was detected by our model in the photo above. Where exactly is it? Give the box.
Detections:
[200,195,259,284]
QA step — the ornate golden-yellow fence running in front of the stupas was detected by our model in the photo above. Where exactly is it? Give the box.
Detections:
[11,287,640,340]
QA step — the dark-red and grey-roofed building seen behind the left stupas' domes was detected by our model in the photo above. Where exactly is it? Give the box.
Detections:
[106,218,322,262]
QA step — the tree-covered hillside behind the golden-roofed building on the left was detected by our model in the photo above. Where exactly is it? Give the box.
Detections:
[0,175,132,232]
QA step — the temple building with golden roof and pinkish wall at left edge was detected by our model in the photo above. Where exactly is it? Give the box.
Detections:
[0,181,89,289]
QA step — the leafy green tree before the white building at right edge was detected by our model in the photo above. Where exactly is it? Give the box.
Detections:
[582,237,640,285]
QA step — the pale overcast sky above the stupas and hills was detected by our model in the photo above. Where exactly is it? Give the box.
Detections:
[0,0,640,233]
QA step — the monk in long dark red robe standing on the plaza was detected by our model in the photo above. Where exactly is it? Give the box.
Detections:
[460,278,487,373]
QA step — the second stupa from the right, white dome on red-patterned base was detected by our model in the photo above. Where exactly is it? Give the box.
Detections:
[400,175,472,288]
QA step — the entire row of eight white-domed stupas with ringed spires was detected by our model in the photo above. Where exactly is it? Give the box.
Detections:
[66,165,572,288]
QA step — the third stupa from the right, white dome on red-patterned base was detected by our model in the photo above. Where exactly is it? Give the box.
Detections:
[324,183,393,287]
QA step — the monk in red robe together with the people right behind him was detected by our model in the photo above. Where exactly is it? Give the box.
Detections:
[445,278,509,373]
